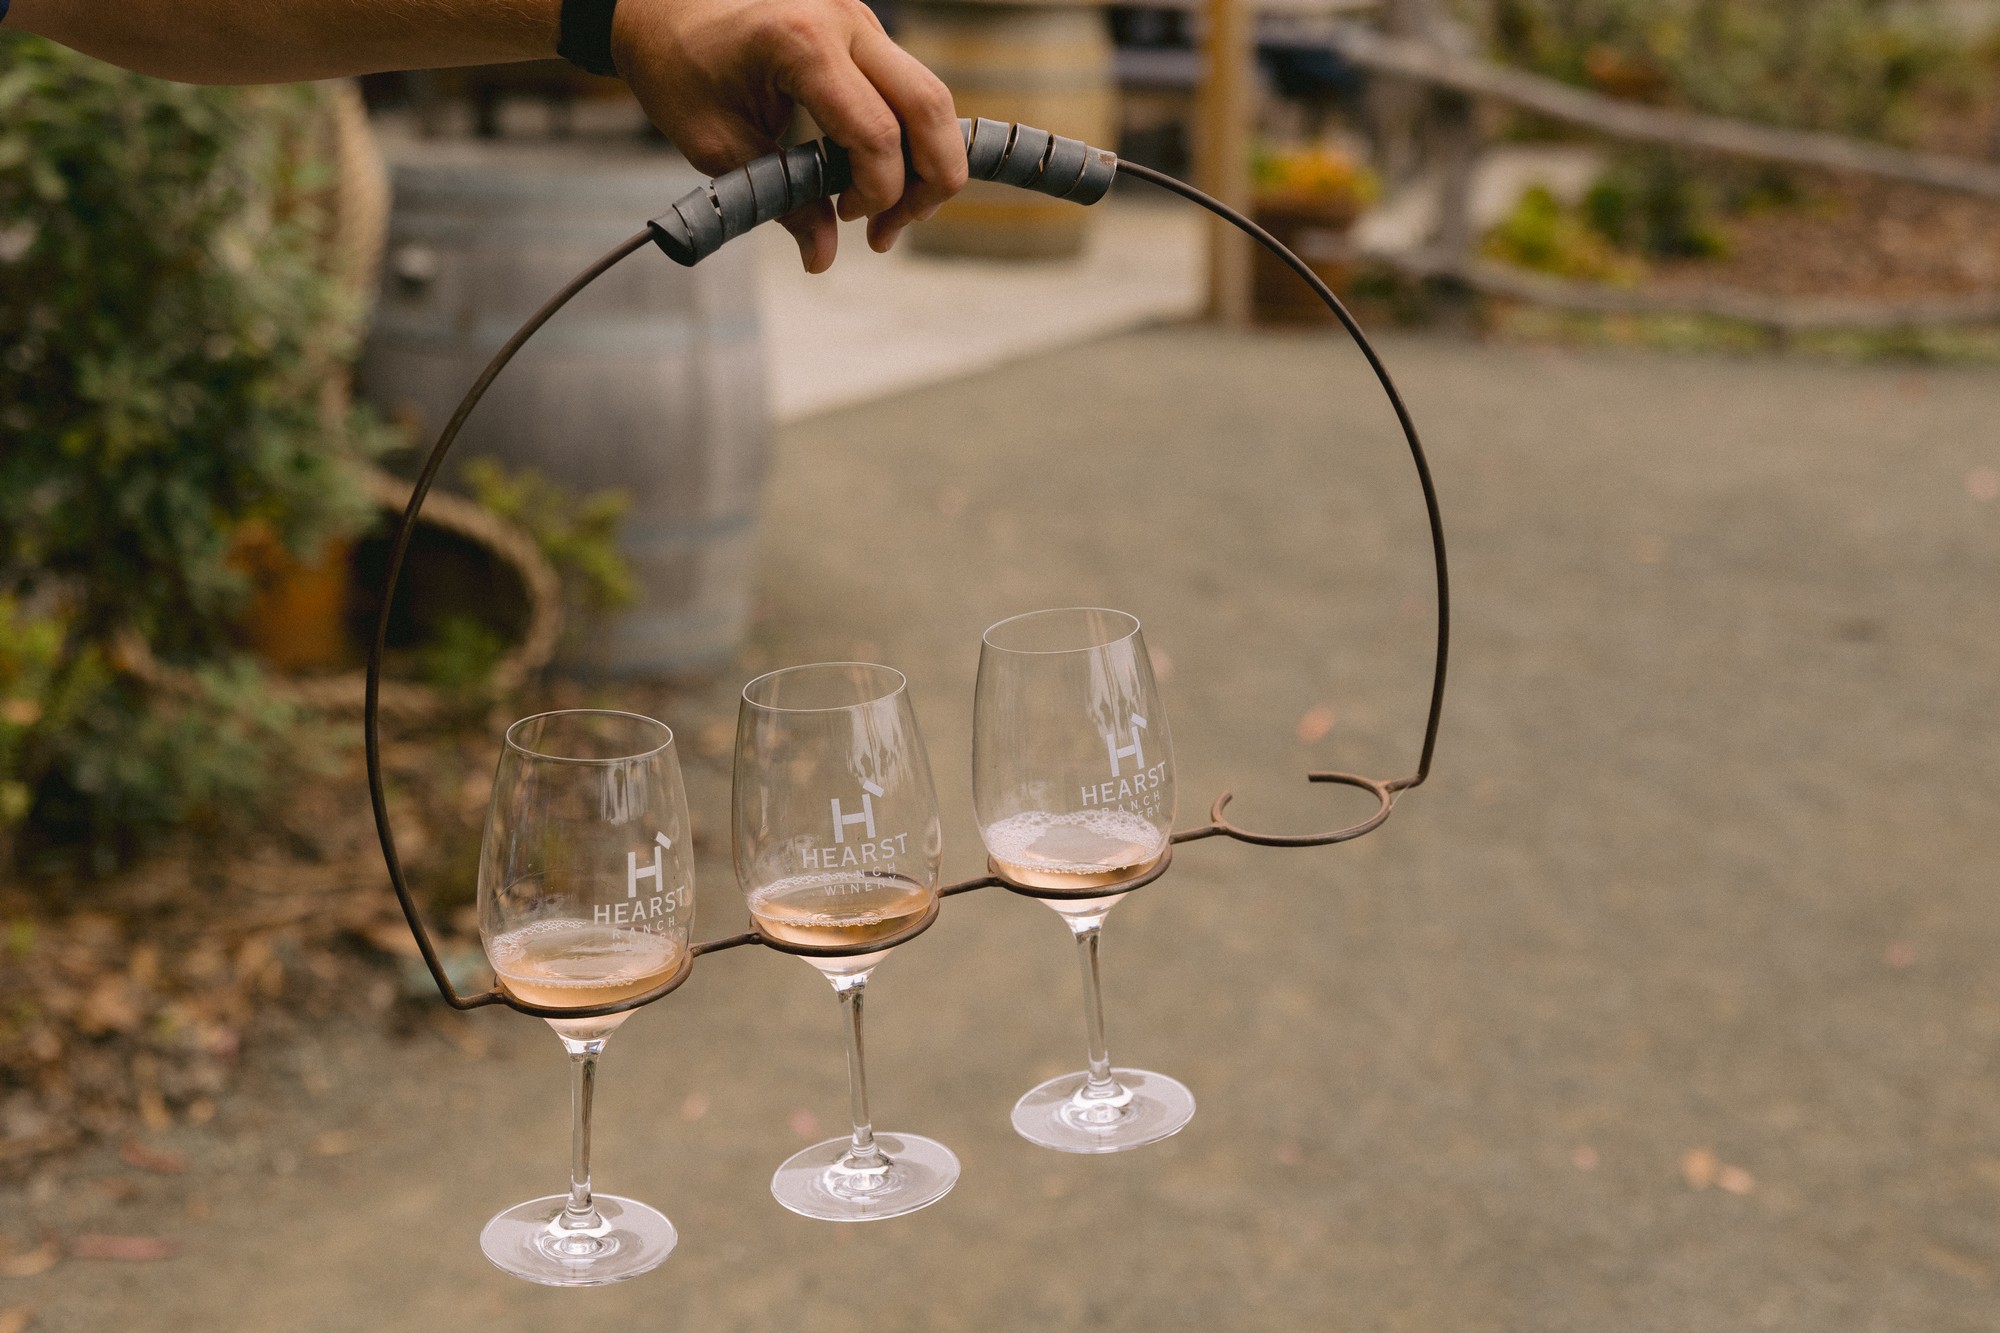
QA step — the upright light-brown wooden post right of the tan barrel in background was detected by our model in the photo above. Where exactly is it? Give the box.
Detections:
[1198,0,1256,328]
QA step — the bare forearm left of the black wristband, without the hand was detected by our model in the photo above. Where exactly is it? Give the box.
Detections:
[6,0,562,84]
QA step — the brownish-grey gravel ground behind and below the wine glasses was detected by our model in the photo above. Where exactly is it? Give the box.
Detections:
[15,330,2000,1333]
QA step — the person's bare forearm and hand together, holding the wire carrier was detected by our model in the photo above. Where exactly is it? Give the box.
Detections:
[6,0,966,272]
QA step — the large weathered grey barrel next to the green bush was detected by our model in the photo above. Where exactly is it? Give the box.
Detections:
[360,142,770,677]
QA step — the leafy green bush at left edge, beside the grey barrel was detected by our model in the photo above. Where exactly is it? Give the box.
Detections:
[0,36,388,871]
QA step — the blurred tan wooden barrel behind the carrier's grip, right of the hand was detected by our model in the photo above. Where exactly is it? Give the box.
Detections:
[898,0,1118,258]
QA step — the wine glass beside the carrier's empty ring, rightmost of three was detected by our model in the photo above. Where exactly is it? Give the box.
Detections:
[972,606,1194,1153]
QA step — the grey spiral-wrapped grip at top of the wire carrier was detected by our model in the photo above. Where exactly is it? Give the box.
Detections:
[646,118,1118,266]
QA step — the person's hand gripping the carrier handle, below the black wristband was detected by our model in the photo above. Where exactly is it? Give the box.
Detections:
[612,0,966,272]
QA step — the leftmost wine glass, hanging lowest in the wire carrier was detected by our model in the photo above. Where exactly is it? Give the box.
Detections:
[480,709,694,1287]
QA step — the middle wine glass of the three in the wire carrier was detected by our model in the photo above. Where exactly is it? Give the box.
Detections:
[734,662,958,1221]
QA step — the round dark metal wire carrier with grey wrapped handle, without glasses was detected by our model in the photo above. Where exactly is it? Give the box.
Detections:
[362,120,1452,1019]
